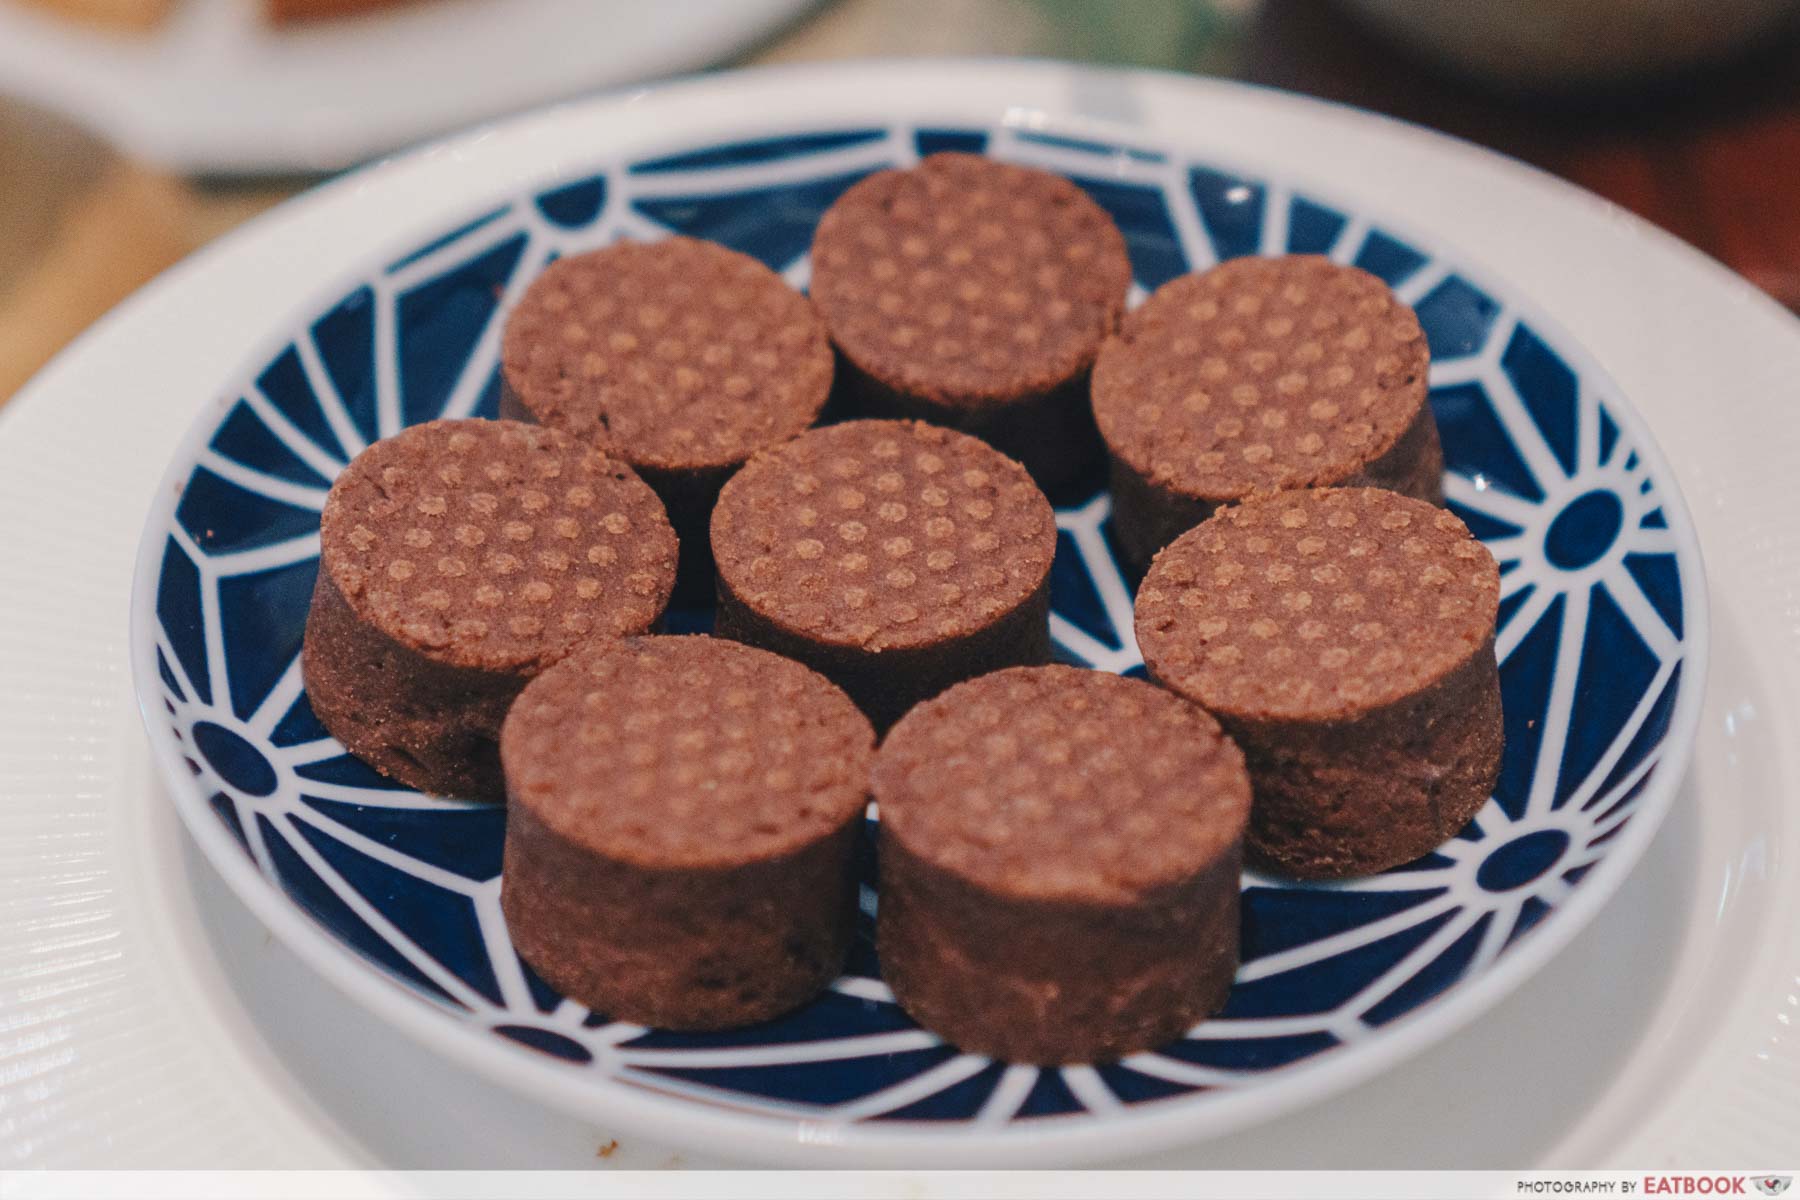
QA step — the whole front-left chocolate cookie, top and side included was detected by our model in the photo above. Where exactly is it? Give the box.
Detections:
[500,637,875,1029]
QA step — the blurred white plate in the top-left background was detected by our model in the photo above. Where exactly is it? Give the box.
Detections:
[0,0,812,175]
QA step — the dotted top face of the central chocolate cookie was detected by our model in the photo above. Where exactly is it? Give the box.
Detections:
[713,421,1057,651]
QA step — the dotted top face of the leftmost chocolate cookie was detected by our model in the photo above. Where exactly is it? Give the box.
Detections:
[319,419,675,671]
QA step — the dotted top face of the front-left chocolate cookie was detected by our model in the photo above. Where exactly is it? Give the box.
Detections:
[500,637,875,867]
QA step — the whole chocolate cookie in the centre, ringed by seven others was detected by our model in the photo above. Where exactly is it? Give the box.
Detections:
[713,421,1057,729]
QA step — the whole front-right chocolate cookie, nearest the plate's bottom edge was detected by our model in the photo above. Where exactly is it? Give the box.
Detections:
[873,666,1251,1065]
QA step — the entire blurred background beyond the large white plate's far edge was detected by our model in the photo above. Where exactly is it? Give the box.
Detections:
[0,0,1800,405]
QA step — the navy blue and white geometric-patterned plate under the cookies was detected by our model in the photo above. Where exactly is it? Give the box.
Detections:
[133,107,1705,1160]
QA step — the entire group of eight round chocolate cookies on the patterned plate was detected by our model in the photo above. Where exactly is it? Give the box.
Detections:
[304,155,1501,1063]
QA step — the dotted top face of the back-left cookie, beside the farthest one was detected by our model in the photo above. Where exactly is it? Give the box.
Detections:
[500,237,832,470]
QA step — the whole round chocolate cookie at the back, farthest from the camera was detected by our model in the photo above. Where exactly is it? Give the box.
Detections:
[810,153,1130,489]
